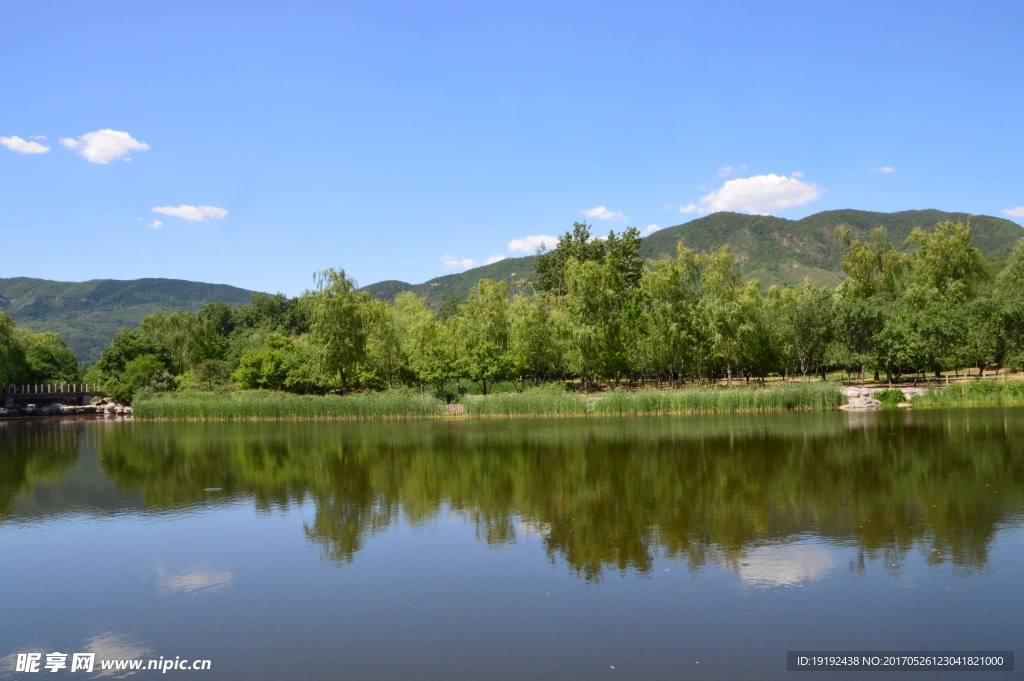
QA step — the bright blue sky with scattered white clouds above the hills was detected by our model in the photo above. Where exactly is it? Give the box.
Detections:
[0,0,1024,295]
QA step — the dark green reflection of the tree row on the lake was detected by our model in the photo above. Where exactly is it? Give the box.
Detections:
[24,409,1024,582]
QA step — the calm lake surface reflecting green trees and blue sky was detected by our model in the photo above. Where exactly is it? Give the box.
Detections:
[0,409,1024,681]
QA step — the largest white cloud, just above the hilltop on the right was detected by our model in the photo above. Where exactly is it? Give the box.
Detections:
[679,174,824,215]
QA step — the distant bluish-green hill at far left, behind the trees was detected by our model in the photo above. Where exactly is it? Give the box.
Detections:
[0,276,253,361]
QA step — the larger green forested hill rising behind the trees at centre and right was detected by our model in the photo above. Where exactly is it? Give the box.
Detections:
[365,210,1024,305]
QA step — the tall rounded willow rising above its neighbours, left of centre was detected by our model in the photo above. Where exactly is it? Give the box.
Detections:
[307,267,369,394]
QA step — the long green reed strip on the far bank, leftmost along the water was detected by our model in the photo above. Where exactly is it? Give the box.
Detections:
[134,390,443,421]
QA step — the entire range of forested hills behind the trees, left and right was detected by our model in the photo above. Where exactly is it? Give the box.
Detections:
[0,210,1024,363]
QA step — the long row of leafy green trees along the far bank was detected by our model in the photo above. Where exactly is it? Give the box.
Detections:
[8,222,1024,401]
